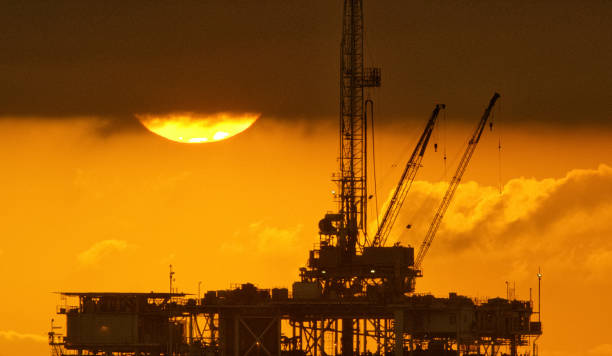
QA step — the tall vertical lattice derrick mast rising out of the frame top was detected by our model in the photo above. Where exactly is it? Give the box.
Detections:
[338,0,380,255]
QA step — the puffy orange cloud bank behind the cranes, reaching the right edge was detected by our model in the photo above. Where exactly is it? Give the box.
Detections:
[398,164,612,281]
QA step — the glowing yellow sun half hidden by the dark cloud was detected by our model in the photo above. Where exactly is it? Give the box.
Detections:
[135,113,261,143]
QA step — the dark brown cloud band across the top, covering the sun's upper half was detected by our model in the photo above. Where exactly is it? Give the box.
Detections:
[0,0,612,128]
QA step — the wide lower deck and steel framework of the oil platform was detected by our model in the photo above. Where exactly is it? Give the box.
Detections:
[49,290,541,356]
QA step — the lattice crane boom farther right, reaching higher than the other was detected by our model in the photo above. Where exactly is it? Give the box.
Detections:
[414,93,499,268]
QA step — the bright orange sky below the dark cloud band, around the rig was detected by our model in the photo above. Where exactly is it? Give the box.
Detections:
[0,116,612,356]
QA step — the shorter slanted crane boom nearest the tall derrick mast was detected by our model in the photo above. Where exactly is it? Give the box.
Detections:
[372,104,445,246]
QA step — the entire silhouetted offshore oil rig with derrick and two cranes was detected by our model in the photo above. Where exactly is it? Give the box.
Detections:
[49,0,542,356]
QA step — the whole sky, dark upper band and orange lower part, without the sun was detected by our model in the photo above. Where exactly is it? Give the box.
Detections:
[0,0,612,356]
